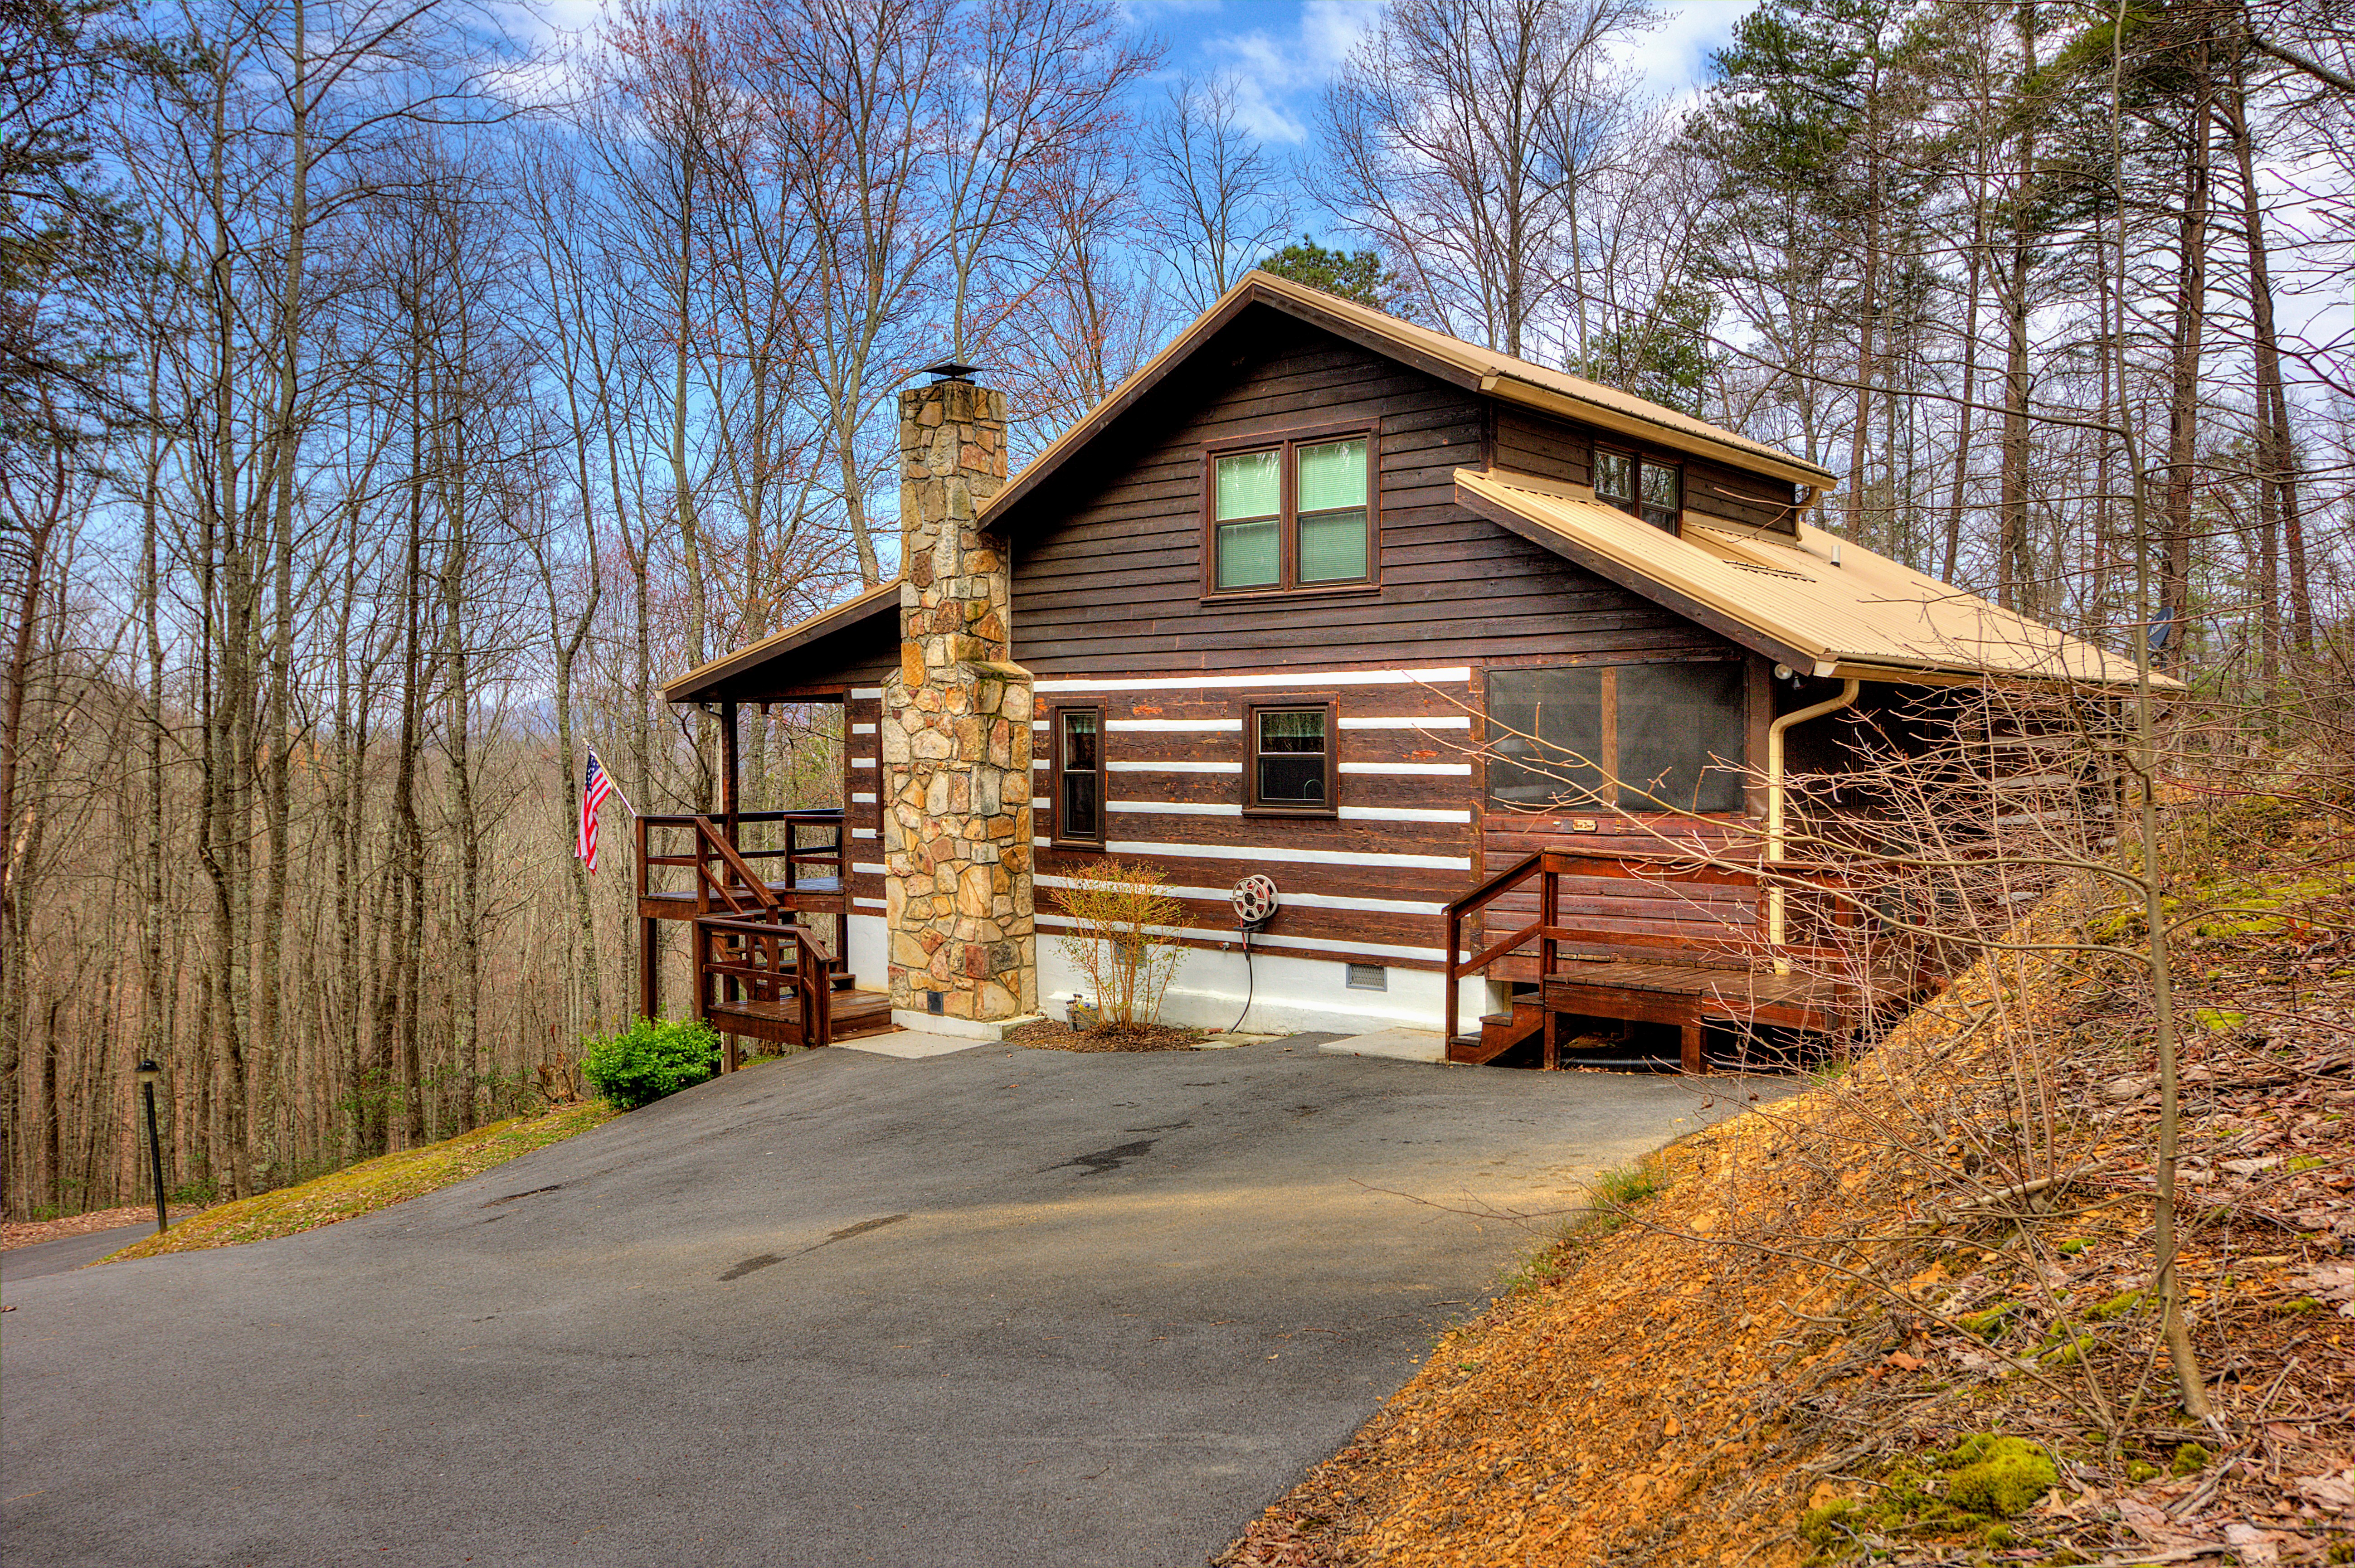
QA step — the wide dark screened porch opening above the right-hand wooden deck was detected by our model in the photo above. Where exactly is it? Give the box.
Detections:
[1489,659,1747,815]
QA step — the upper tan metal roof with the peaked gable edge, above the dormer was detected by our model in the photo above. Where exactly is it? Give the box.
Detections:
[980,271,1839,523]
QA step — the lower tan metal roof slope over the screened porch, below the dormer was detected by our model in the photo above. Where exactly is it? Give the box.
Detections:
[1455,469,2178,688]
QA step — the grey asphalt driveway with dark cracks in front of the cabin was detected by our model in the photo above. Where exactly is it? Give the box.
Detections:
[0,1043,1771,1568]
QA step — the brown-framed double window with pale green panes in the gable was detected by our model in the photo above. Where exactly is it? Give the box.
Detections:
[1206,431,1375,593]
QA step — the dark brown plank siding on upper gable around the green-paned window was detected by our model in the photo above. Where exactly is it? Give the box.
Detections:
[1012,311,1724,680]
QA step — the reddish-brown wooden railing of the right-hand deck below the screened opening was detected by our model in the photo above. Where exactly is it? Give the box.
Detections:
[1446,850,1877,1041]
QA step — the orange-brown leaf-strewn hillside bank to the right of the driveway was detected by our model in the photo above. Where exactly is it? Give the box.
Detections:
[1215,798,2355,1568]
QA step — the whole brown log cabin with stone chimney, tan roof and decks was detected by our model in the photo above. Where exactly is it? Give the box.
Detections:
[638,273,2134,1069]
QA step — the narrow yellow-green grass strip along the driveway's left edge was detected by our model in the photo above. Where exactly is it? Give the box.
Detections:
[106,1102,615,1262]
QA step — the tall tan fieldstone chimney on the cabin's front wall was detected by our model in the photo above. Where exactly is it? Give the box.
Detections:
[881,367,1039,1038]
